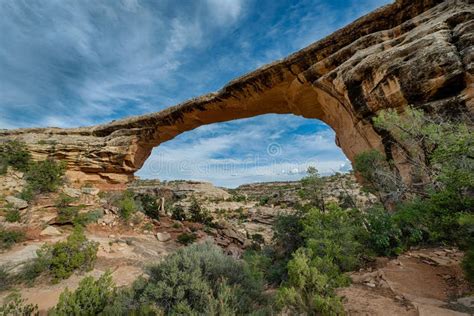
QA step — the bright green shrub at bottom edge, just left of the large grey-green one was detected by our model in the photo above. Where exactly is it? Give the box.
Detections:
[48,272,116,316]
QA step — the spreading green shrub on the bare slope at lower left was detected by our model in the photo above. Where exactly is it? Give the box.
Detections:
[20,226,98,283]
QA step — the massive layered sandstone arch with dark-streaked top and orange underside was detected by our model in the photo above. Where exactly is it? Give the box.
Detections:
[0,0,474,188]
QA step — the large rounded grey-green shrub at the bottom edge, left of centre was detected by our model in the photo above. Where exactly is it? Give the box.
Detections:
[134,243,266,315]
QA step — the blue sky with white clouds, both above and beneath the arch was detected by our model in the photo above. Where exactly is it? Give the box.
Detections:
[0,0,390,186]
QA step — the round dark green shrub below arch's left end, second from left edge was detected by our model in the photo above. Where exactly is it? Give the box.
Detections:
[26,159,66,193]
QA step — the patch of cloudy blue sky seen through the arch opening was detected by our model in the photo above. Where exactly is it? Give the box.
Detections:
[137,115,347,187]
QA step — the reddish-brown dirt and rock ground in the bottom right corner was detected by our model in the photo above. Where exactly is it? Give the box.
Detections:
[338,248,474,316]
